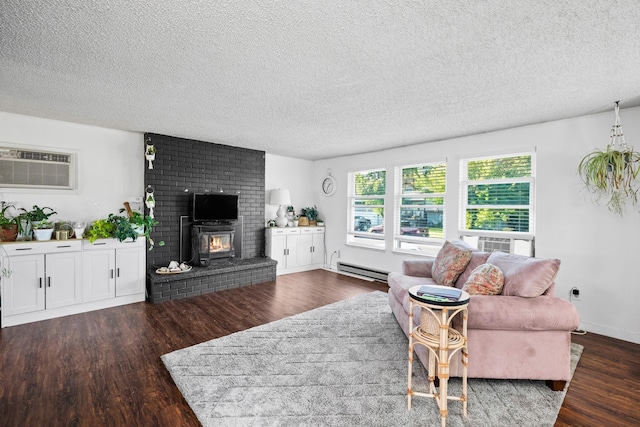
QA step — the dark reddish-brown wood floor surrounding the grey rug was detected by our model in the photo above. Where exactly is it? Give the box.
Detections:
[0,270,640,427]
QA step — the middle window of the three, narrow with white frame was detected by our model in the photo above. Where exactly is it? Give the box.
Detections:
[393,162,447,255]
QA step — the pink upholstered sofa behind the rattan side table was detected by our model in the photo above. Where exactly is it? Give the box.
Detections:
[389,241,580,390]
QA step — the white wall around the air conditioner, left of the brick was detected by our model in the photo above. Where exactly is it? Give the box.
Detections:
[0,112,144,221]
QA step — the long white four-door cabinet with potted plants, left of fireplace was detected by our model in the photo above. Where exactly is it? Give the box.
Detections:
[0,238,146,328]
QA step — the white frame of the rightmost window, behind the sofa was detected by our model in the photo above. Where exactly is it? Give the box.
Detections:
[458,150,536,241]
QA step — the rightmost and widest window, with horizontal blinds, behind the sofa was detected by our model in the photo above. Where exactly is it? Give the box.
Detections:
[460,153,535,239]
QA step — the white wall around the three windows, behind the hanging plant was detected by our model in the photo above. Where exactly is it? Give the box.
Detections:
[313,108,640,343]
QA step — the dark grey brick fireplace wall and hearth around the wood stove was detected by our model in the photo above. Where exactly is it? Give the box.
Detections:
[145,133,275,303]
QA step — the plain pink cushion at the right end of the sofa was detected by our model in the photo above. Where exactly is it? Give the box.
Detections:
[487,252,560,297]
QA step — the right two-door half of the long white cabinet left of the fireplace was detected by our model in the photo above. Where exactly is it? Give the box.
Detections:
[82,238,146,302]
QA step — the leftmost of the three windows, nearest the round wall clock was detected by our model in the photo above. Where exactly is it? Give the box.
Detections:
[347,169,387,249]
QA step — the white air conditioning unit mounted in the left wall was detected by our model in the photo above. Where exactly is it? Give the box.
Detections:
[0,147,75,190]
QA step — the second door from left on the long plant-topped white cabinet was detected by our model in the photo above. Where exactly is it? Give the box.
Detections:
[45,252,82,308]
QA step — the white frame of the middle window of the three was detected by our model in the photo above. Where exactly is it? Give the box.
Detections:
[393,159,449,256]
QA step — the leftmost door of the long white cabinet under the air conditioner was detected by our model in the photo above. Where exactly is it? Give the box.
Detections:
[2,255,45,316]
